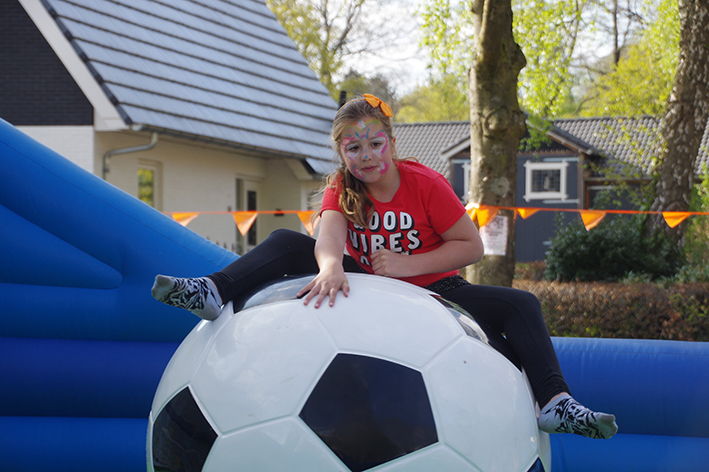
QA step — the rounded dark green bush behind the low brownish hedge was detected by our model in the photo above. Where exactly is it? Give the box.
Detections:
[545,215,682,282]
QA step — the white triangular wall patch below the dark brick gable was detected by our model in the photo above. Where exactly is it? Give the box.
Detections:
[18,126,96,174]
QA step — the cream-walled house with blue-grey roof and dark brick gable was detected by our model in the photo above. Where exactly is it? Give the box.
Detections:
[0,0,337,253]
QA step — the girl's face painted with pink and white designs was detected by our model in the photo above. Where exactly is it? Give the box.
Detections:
[340,118,394,184]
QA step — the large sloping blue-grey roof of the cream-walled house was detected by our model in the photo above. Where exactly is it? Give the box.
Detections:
[34,0,337,173]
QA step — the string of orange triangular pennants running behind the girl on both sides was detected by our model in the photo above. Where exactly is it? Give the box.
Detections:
[163,203,709,236]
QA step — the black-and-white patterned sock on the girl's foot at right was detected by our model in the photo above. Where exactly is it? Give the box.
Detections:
[538,395,618,439]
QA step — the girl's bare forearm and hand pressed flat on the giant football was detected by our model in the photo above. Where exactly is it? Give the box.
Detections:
[298,210,350,308]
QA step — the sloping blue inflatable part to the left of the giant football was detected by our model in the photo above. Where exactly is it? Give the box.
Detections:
[0,115,236,472]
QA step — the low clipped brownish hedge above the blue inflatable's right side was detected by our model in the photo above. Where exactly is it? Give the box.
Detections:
[513,277,709,341]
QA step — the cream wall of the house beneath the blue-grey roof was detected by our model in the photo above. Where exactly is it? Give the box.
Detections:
[94,132,302,250]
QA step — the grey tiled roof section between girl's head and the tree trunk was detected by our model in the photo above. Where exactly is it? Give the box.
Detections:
[394,121,470,177]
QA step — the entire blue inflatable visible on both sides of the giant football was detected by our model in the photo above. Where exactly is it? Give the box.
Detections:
[0,120,709,472]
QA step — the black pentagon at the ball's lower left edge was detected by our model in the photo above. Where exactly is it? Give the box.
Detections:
[152,388,217,472]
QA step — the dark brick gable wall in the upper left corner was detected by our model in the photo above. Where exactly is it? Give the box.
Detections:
[0,0,93,126]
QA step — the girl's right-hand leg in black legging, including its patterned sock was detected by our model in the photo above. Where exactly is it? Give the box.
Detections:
[442,285,618,438]
